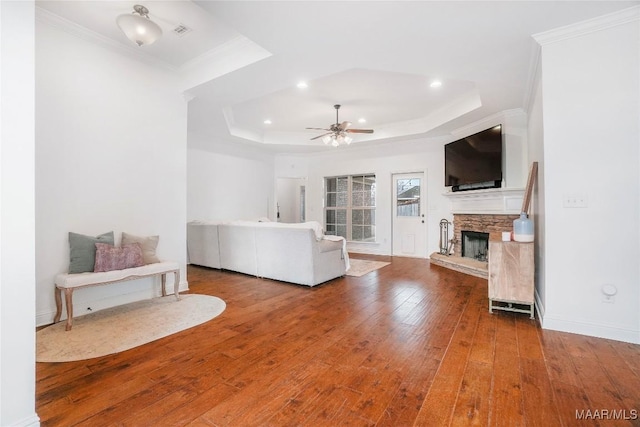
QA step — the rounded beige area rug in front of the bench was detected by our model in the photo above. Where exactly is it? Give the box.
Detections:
[36,294,226,362]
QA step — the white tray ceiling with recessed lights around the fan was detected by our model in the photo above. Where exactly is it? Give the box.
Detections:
[37,0,640,152]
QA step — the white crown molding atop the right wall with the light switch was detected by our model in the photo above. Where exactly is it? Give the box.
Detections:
[533,6,640,46]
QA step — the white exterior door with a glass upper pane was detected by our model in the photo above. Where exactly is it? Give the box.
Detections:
[392,172,427,258]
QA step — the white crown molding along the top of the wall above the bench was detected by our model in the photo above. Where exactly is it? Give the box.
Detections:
[35,6,177,72]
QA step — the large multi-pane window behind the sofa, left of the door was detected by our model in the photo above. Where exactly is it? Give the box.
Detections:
[324,175,376,242]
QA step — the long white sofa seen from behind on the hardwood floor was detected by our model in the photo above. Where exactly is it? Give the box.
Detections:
[187,221,348,286]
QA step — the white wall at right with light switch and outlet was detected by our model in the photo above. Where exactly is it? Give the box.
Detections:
[542,13,640,343]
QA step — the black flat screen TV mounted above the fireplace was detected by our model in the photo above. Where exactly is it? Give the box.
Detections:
[444,125,502,191]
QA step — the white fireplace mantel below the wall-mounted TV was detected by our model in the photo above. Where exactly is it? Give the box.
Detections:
[443,188,524,215]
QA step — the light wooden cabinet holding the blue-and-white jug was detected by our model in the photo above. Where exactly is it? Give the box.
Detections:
[489,240,535,319]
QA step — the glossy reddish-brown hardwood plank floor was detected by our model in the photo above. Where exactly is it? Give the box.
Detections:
[36,255,640,426]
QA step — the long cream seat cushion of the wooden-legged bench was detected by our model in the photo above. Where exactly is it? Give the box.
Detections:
[55,261,180,288]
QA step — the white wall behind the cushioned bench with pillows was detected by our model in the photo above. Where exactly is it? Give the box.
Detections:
[36,17,187,323]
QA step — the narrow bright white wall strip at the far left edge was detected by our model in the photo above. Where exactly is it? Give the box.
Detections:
[0,1,39,426]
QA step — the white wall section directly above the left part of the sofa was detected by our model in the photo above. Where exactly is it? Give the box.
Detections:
[187,145,275,221]
